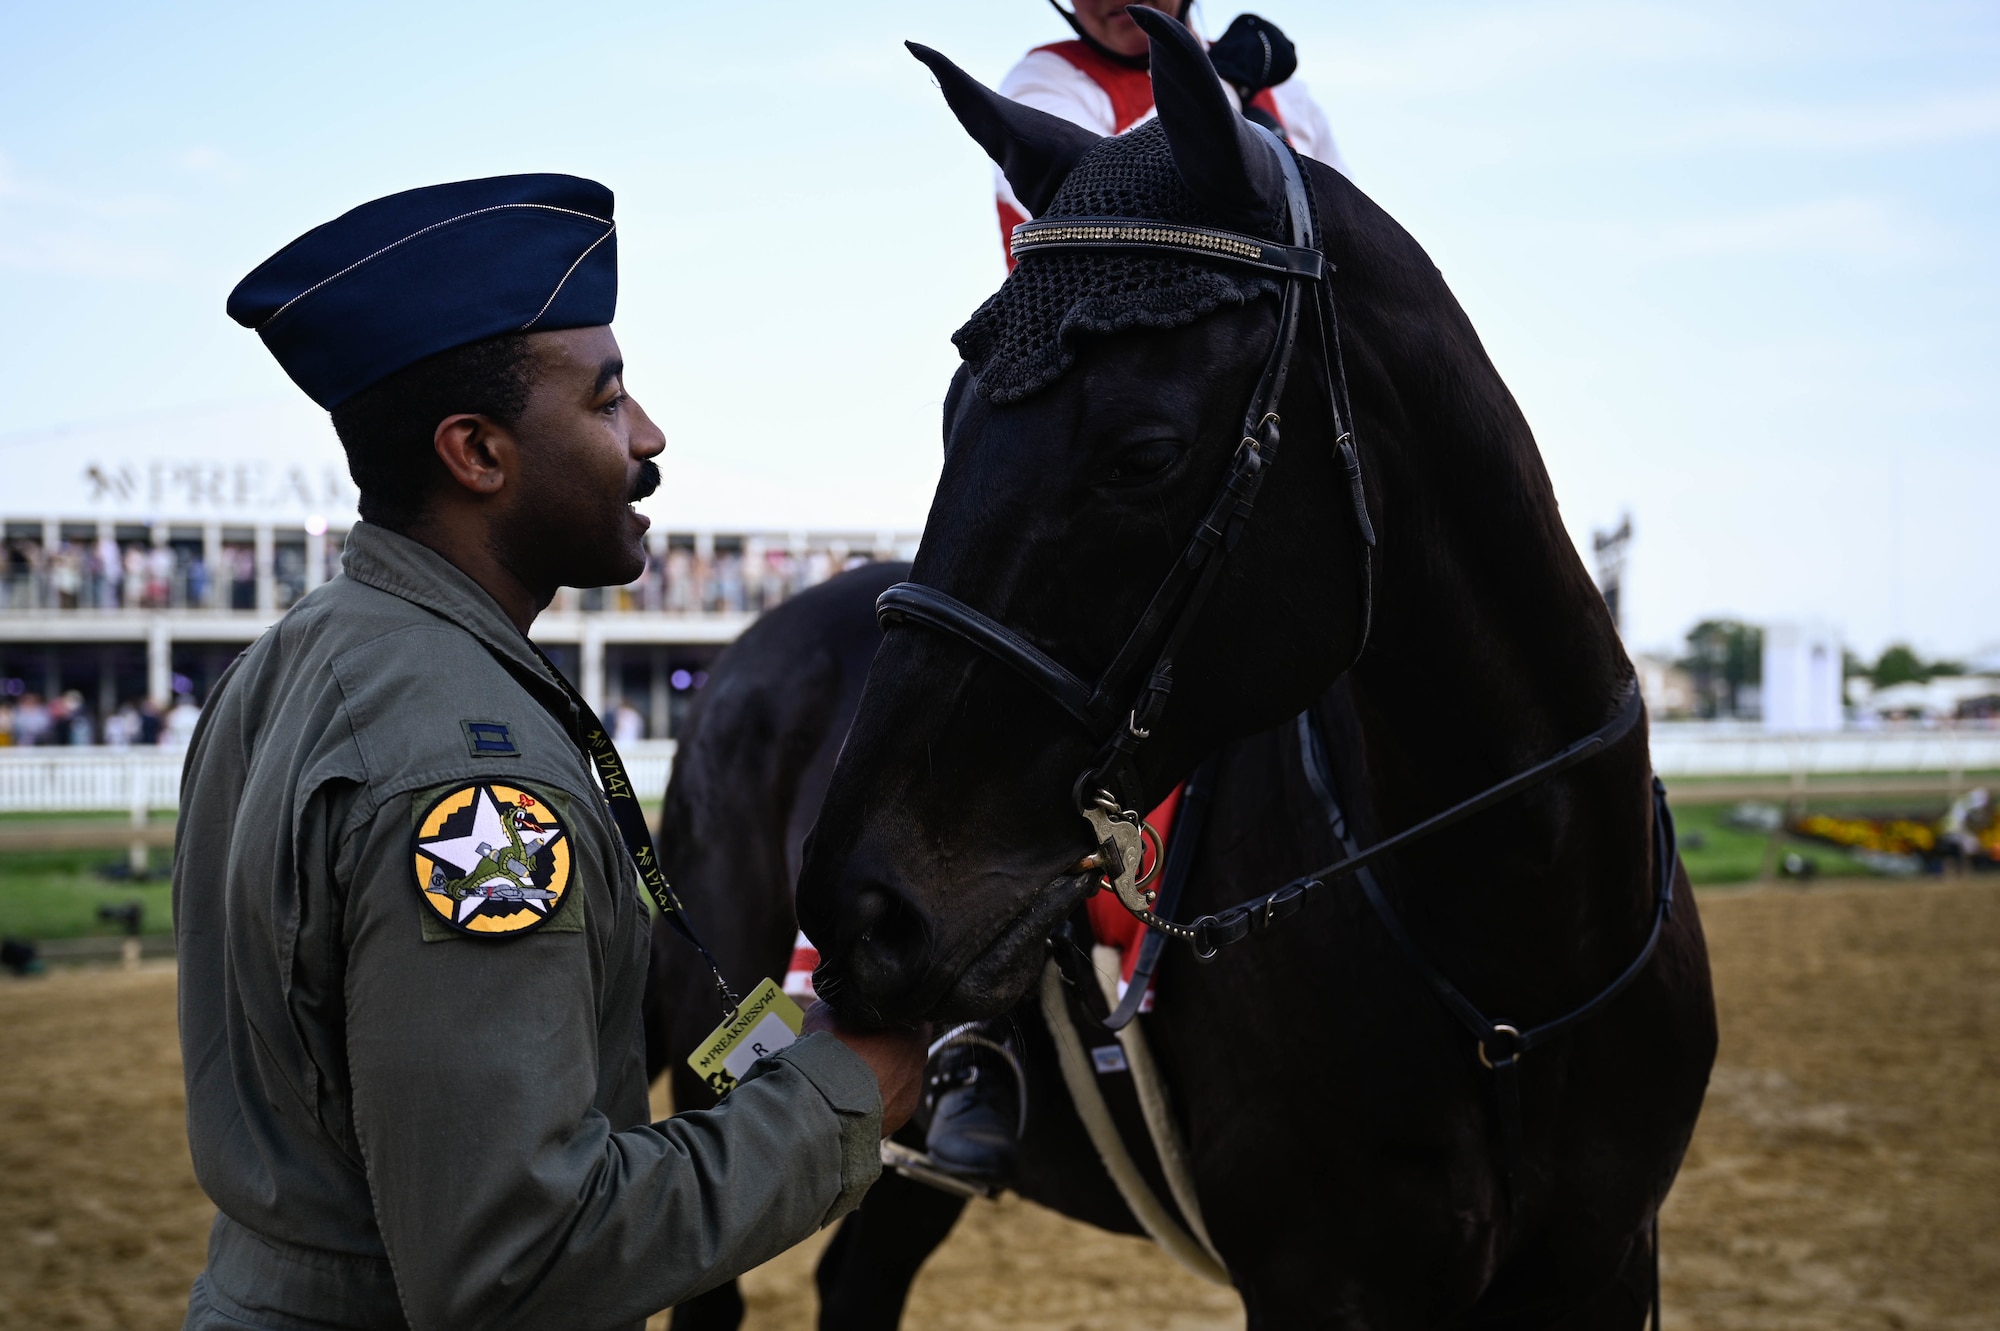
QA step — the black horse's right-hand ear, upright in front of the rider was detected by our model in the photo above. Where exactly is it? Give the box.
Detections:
[1126,4,1284,230]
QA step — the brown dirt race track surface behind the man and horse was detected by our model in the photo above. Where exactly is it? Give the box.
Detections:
[0,881,2000,1331]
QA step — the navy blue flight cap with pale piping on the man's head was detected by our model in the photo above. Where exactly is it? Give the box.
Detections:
[228,176,618,412]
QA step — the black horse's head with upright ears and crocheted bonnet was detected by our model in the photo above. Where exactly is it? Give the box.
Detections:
[798,8,1372,1023]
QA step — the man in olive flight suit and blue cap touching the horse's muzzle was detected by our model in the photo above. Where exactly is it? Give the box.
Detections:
[174,176,924,1331]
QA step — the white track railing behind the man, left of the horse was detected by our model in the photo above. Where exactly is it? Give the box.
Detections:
[0,739,674,813]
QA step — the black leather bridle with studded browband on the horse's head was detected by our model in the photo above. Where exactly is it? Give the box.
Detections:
[876,122,1374,923]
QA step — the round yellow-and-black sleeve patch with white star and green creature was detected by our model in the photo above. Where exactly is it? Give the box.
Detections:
[412,781,570,937]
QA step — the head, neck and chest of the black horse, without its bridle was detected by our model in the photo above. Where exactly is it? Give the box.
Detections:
[798,10,1716,1327]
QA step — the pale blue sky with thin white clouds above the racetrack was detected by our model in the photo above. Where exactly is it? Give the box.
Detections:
[0,0,2000,656]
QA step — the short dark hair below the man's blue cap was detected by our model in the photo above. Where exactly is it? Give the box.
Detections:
[332,334,534,532]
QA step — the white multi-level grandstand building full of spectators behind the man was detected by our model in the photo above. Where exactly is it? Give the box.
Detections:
[0,404,916,743]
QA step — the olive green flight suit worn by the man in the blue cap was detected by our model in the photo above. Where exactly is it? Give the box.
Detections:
[174,524,882,1331]
